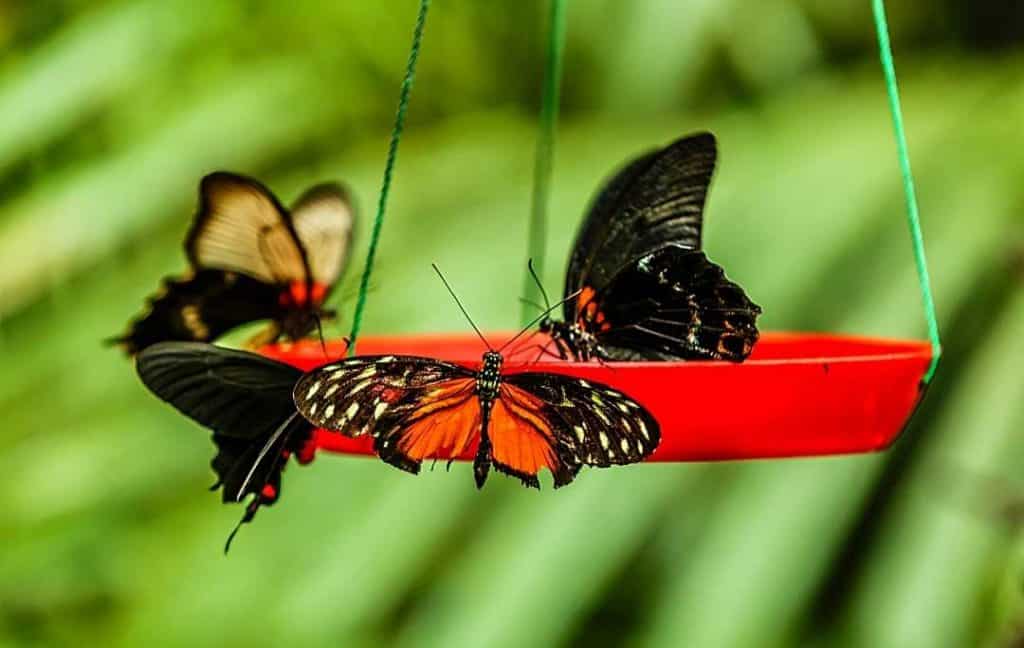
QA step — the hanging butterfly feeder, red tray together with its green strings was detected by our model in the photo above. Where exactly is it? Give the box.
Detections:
[262,0,940,462]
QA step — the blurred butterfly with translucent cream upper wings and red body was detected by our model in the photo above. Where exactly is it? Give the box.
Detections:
[113,172,354,354]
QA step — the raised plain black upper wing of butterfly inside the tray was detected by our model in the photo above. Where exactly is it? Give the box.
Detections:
[564,133,717,321]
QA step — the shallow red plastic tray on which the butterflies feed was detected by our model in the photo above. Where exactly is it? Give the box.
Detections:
[262,333,931,462]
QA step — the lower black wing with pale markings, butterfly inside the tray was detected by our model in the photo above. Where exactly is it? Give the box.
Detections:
[580,245,761,362]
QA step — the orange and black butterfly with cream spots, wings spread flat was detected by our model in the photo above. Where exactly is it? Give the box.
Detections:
[294,350,660,488]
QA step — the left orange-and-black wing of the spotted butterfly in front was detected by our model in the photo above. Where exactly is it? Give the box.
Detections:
[294,355,480,473]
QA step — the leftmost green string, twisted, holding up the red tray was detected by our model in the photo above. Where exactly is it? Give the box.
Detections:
[348,0,430,356]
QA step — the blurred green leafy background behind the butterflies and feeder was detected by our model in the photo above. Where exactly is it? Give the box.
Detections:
[0,0,1024,648]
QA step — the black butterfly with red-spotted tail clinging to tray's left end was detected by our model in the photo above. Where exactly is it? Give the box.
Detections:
[135,342,313,552]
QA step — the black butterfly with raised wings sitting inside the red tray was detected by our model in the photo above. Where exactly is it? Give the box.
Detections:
[540,133,761,361]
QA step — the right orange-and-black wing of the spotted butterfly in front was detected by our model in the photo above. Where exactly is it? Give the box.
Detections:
[499,372,662,487]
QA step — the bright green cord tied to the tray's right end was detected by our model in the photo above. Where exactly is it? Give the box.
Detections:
[871,0,942,385]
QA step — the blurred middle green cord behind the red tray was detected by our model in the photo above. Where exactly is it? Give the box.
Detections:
[521,0,565,327]
